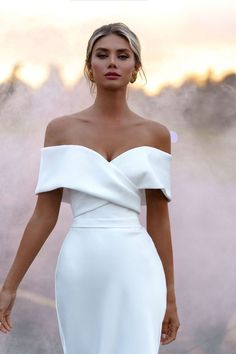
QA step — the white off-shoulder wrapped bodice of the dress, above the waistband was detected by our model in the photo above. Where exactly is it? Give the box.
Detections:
[35,145,172,215]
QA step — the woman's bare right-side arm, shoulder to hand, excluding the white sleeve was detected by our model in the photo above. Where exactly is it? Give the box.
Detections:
[146,126,180,344]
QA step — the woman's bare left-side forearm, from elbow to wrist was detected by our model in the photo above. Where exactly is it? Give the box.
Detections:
[3,214,55,291]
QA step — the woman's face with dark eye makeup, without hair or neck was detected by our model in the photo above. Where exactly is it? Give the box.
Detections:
[90,34,135,88]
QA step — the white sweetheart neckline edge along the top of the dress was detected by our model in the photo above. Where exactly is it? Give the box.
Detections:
[41,144,172,164]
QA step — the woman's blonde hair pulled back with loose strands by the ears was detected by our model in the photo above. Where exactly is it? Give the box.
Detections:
[84,22,146,90]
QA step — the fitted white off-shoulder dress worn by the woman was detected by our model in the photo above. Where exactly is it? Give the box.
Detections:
[35,145,172,354]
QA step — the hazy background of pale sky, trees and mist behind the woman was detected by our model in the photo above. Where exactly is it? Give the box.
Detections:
[0,0,236,354]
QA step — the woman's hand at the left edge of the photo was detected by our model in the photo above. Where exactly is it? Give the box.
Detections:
[0,289,16,333]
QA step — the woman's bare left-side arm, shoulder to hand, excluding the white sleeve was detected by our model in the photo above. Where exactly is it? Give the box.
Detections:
[0,121,63,333]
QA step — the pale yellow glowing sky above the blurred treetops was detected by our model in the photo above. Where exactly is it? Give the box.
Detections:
[0,0,236,94]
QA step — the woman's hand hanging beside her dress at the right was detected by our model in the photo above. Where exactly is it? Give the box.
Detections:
[161,302,180,344]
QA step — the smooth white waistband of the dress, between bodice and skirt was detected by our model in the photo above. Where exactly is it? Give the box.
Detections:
[70,214,142,228]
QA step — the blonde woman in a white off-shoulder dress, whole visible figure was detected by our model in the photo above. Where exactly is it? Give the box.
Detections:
[0,23,179,354]
